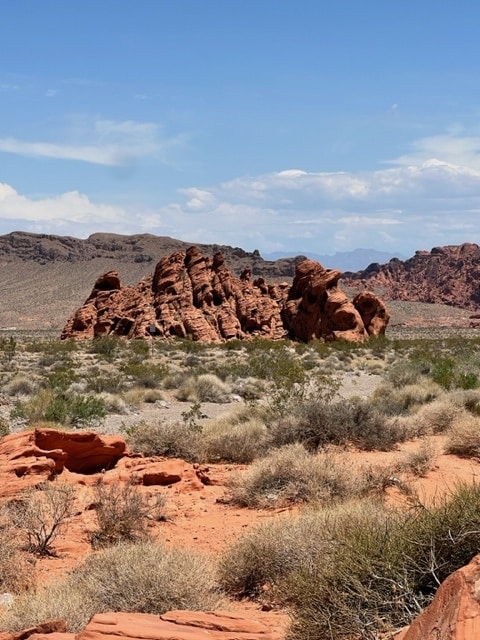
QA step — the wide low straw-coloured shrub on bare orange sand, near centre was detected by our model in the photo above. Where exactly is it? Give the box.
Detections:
[230,444,363,507]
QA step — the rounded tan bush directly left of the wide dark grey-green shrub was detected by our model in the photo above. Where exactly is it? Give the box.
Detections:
[200,414,268,464]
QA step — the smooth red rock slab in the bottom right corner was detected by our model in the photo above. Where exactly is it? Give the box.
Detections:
[396,555,480,640]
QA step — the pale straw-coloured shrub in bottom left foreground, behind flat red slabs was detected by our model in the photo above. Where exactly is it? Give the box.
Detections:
[0,542,218,632]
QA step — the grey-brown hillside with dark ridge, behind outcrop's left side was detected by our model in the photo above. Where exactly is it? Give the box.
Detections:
[0,231,304,330]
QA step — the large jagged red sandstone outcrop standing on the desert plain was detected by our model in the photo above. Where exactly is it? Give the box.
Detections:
[61,247,389,342]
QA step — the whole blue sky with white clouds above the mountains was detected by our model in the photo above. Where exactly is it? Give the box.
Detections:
[0,0,480,255]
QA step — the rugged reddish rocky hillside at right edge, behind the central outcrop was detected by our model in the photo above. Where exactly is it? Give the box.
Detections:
[343,243,480,311]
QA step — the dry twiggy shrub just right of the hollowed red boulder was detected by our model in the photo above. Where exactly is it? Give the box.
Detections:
[126,422,200,460]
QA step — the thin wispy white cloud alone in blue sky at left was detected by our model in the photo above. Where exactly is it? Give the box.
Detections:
[0,116,182,167]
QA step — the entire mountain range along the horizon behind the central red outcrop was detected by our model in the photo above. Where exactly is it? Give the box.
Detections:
[0,232,480,330]
